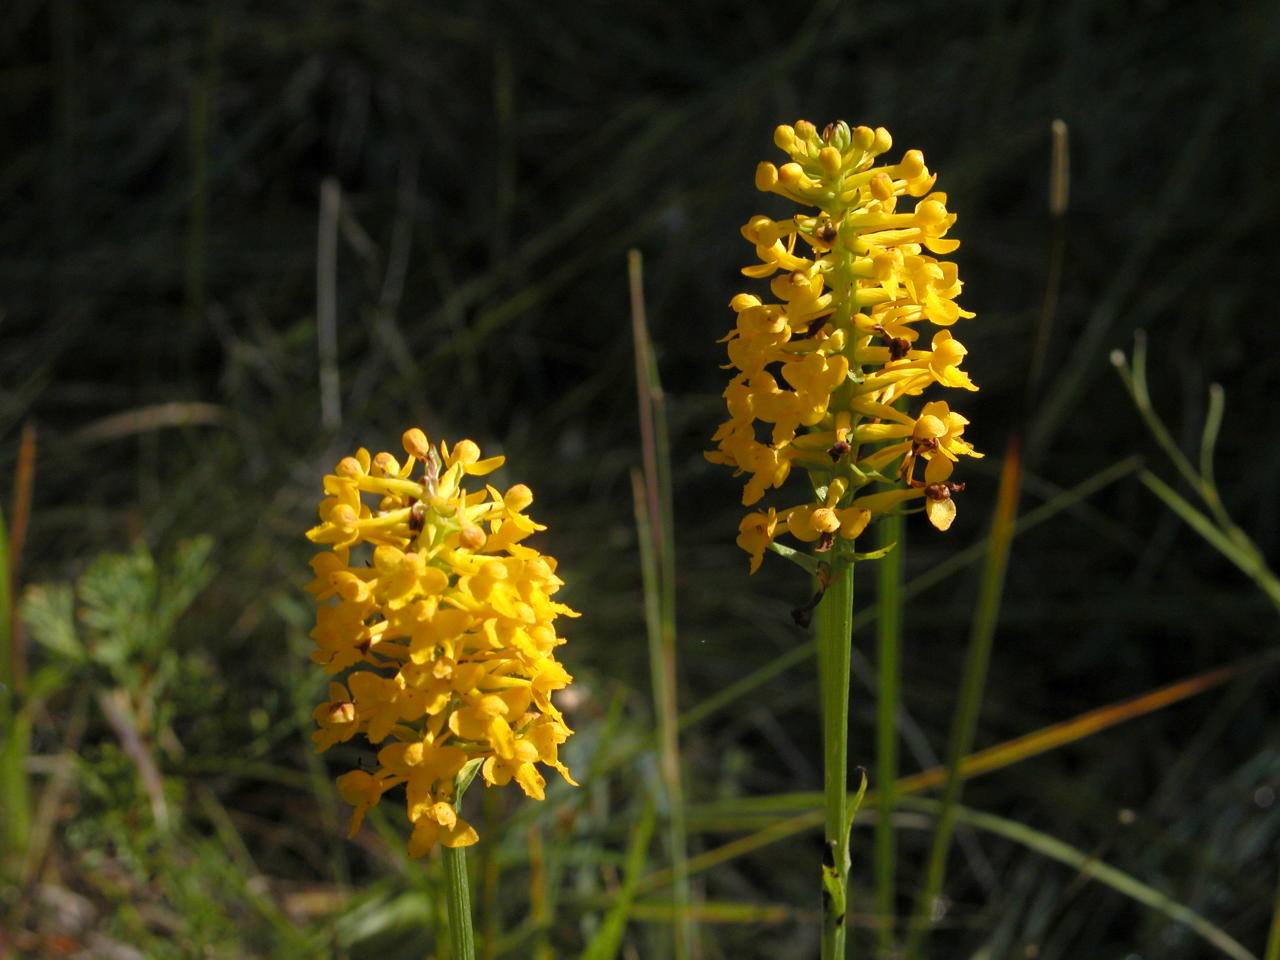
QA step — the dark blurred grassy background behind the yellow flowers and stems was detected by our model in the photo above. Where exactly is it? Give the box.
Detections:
[0,0,1280,960]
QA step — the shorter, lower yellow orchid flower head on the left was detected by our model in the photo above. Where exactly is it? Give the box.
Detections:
[307,428,577,856]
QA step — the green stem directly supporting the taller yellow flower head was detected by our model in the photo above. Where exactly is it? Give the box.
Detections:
[814,562,854,960]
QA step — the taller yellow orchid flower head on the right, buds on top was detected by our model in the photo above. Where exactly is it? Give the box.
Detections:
[707,120,982,573]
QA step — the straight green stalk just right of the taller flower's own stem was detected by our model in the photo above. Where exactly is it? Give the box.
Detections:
[874,515,904,957]
